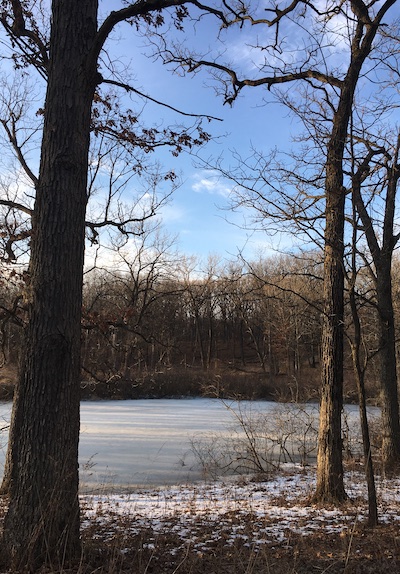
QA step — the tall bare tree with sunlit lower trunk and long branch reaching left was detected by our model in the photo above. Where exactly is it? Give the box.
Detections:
[156,0,396,502]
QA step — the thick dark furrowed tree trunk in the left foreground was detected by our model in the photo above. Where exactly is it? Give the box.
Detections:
[3,0,97,569]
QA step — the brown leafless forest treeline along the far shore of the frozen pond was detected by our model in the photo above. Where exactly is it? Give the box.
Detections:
[1,252,400,402]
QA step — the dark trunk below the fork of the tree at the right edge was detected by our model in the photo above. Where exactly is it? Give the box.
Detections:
[376,262,400,472]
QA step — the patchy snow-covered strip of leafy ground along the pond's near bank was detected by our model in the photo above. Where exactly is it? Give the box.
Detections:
[82,467,400,552]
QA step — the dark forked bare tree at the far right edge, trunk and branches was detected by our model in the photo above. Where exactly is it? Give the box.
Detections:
[351,128,400,472]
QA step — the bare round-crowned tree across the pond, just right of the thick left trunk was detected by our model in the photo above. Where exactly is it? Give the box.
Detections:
[83,220,184,380]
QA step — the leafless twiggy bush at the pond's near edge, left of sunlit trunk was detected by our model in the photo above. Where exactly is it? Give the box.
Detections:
[191,401,380,478]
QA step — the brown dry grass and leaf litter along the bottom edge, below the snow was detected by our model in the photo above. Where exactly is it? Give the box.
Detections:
[72,514,400,574]
